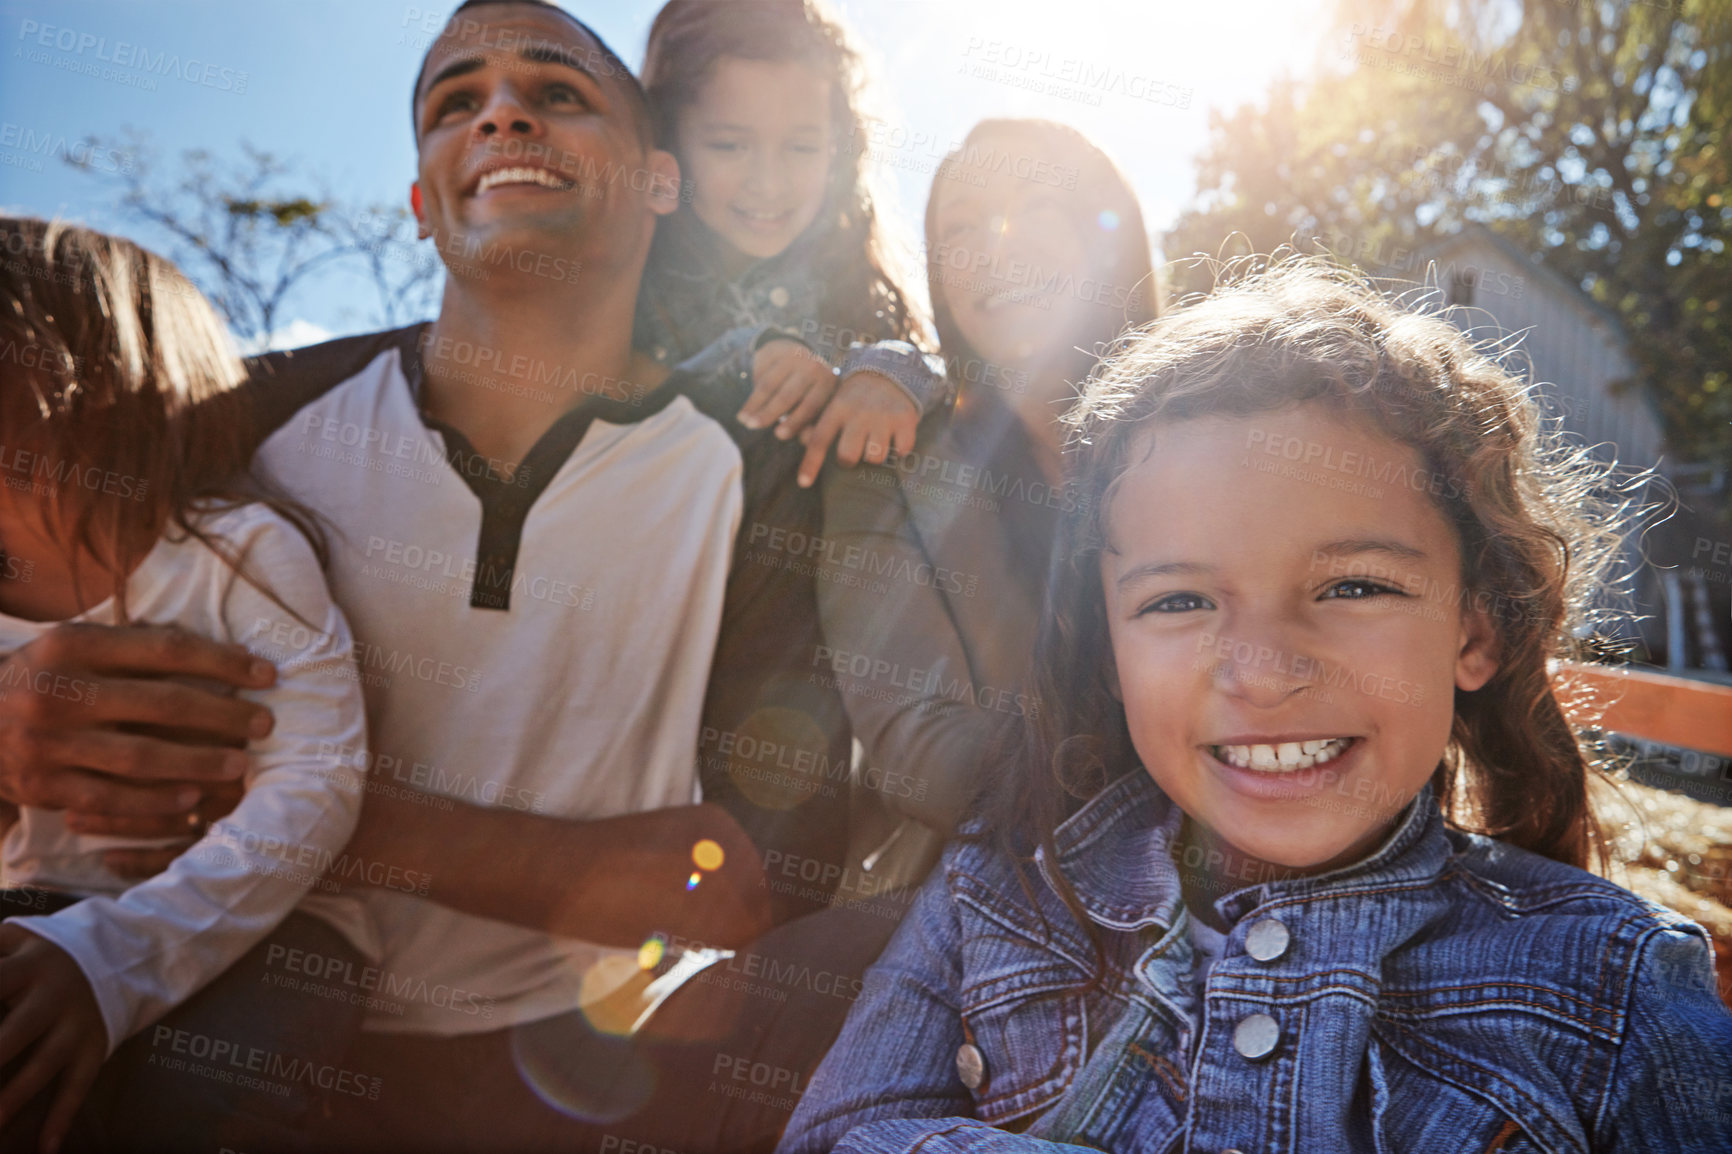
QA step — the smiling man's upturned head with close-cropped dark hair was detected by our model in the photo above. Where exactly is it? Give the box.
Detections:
[416,5,679,279]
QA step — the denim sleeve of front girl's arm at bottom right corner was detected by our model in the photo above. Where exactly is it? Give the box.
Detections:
[1587,927,1732,1154]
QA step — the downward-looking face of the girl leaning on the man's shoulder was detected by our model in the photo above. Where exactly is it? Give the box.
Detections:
[677,55,837,260]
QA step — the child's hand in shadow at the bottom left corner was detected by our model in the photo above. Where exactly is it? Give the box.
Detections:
[0,924,107,1151]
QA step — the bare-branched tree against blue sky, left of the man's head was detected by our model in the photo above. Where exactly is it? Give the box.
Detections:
[66,133,440,348]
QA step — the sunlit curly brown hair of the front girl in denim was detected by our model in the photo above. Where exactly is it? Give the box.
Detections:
[982,258,1625,925]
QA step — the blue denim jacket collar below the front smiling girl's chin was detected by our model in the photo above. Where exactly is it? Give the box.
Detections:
[1036,768,1451,930]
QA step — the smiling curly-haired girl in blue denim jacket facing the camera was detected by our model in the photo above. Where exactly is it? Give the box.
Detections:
[781,263,1732,1154]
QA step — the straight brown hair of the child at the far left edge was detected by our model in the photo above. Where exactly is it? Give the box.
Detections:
[0,217,326,619]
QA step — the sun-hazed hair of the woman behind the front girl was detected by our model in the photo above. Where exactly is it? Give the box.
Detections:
[925,118,1159,395]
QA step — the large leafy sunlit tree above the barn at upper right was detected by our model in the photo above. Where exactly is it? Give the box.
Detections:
[1166,0,1732,485]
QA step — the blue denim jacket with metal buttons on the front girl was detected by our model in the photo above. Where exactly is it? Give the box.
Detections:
[779,773,1732,1154]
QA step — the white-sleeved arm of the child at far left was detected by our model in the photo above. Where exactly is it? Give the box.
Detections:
[2,506,365,1052]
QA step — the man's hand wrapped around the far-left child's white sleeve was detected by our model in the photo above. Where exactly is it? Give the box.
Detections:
[0,624,277,837]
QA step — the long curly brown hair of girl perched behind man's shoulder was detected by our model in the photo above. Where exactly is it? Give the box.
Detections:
[643,0,932,348]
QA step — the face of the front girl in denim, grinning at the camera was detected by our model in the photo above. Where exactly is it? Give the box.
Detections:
[1102,404,1496,872]
